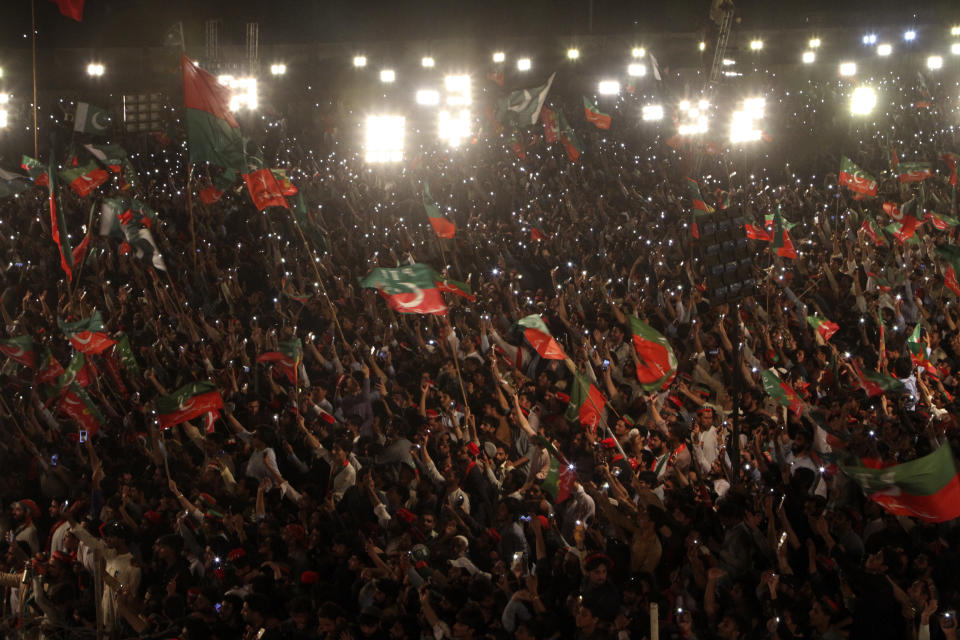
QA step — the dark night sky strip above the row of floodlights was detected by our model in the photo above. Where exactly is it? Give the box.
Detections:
[0,0,960,50]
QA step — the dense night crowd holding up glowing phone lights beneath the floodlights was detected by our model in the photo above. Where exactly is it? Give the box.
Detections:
[0,66,960,640]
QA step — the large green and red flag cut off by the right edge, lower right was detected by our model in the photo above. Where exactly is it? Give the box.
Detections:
[841,445,960,522]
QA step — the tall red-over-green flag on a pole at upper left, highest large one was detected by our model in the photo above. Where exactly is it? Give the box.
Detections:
[180,55,248,172]
